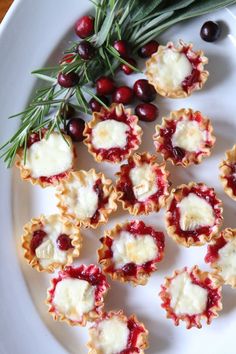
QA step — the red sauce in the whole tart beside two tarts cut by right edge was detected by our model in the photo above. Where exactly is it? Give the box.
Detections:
[168,186,222,241]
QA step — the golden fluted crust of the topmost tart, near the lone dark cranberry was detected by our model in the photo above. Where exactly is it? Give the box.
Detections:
[146,40,209,98]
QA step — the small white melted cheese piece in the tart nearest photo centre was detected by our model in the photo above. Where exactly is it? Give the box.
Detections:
[129,163,158,202]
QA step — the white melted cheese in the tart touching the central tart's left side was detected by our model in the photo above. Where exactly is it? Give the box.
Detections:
[62,173,98,220]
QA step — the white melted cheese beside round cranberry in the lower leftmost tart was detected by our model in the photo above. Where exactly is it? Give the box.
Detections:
[35,215,67,268]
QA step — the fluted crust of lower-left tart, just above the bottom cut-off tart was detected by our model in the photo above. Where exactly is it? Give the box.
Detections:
[45,264,110,327]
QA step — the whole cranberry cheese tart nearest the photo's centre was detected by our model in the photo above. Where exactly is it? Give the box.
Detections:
[116,153,169,215]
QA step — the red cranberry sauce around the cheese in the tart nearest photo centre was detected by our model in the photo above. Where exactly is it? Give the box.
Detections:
[117,156,167,212]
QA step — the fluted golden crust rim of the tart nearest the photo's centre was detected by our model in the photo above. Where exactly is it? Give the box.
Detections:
[116,152,170,215]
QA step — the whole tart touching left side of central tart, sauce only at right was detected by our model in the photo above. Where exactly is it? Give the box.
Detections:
[56,169,117,228]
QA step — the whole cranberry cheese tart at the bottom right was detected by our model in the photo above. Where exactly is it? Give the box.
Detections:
[159,266,222,329]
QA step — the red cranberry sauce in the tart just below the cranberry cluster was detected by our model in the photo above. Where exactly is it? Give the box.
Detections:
[88,108,139,161]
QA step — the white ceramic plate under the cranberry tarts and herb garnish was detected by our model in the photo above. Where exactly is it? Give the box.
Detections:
[0,0,236,354]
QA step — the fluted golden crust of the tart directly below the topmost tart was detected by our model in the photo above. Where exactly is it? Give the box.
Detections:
[153,108,216,167]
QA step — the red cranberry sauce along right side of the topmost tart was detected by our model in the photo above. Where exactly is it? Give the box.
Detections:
[182,46,202,93]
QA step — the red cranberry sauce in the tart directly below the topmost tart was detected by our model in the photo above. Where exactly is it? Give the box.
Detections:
[158,112,212,163]
